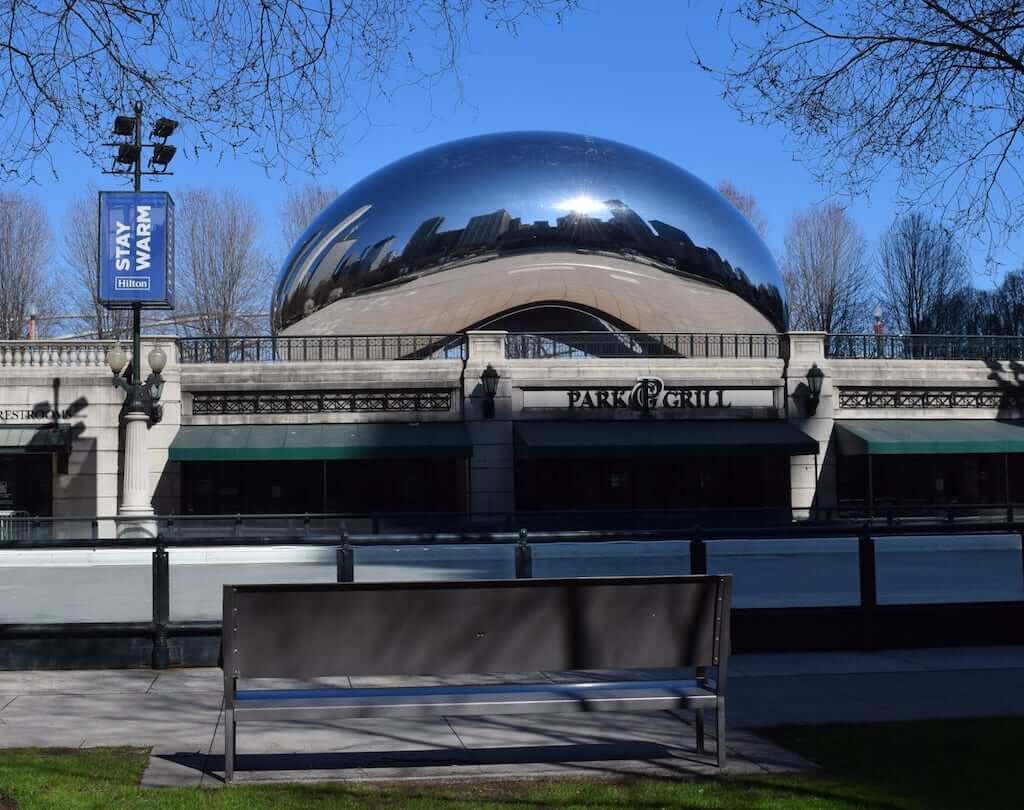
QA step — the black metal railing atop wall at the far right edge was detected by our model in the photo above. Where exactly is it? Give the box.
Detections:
[825,335,1024,361]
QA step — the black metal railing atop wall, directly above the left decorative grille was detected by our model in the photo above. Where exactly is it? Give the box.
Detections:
[178,335,466,365]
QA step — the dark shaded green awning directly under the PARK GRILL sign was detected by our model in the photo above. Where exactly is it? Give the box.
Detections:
[515,420,818,459]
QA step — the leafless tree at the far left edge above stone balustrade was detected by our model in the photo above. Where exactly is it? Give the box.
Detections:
[0,191,56,340]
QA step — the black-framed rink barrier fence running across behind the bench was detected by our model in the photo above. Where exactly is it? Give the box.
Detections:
[0,521,1024,668]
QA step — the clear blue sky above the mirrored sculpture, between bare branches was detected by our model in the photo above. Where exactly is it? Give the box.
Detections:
[18,0,1021,285]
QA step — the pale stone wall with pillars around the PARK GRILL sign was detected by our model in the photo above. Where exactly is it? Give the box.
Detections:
[8,332,1024,517]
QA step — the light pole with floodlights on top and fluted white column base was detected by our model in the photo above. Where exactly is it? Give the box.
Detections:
[103,101,177,536]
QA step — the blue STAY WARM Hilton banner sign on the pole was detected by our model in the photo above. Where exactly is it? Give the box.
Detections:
[97,191,174,309]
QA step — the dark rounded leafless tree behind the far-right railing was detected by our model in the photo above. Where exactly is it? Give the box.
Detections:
[879,212,970,335]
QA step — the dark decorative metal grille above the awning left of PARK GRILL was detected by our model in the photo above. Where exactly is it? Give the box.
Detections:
[193,388,452,416]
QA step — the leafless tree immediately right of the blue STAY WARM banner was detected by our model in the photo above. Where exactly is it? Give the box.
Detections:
[175,188,273,337]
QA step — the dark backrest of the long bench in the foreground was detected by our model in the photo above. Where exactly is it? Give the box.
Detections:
[223,577,731,678]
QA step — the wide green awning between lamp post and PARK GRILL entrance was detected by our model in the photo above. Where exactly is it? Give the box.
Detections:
[169,422,473,461]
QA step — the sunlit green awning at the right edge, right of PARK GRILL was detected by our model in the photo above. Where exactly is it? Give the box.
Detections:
[836,419,1024,456]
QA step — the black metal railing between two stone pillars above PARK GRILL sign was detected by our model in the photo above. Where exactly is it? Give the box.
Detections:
[505,332,780,359]
